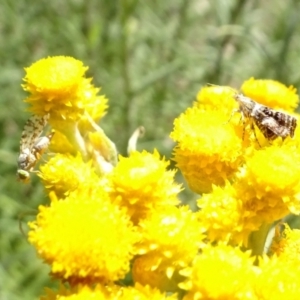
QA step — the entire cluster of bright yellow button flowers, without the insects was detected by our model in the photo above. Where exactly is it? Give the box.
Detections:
[19,56,300,300]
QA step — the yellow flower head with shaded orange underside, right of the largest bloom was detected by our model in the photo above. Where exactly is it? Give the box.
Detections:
[132,206,204,291]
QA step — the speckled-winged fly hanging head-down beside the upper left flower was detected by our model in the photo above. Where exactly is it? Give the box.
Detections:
[17,114,54,182]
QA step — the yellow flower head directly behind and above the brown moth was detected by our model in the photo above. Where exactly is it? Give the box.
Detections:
[241,78,299,112]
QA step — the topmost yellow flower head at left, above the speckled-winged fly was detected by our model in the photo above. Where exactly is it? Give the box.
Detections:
[23,56,107,121]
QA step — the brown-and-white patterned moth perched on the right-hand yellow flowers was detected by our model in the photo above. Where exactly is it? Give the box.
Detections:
[233,93,297,144]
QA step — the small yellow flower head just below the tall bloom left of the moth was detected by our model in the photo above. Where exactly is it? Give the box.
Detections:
[197,182,250,245]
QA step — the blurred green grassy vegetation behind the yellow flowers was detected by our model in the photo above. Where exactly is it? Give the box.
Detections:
[0,0,300,300]
